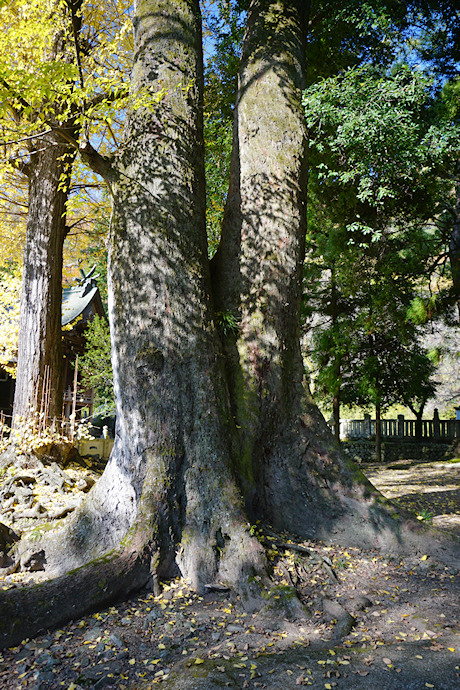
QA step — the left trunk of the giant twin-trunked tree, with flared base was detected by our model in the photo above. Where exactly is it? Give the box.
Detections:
[5,0,265,636]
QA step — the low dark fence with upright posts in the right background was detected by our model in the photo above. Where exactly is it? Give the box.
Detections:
[340,413,460,440]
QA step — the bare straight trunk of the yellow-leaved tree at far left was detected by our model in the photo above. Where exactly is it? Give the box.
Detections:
[13,133,74,420]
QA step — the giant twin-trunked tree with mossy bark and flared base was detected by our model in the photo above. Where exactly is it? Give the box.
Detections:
[0,0,458,644]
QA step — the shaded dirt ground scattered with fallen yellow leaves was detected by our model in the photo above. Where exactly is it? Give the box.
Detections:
[0,454,460,690]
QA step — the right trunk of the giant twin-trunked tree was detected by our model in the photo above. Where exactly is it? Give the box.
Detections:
[213,0,374,535]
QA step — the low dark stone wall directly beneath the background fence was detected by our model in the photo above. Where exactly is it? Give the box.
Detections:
[341,438,452,463]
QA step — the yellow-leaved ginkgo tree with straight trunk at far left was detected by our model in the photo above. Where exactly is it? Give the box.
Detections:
[0,0,132,417]
